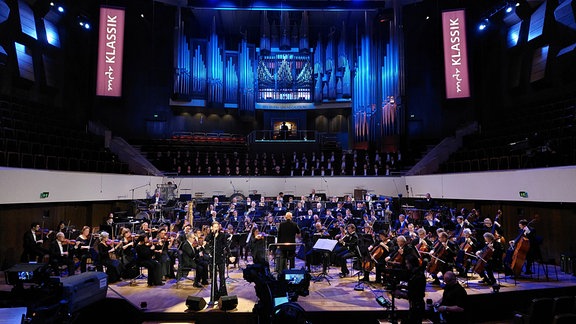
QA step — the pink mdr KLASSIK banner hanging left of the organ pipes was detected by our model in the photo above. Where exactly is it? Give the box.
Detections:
[96,7,124,97]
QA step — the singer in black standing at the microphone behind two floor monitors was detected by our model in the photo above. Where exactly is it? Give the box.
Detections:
[206,222,228,301]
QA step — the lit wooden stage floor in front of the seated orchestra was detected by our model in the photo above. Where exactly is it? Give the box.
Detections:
[2,259,576,324]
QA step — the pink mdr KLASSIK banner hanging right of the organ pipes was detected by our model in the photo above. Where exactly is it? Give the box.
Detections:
[442,10,470,99]
